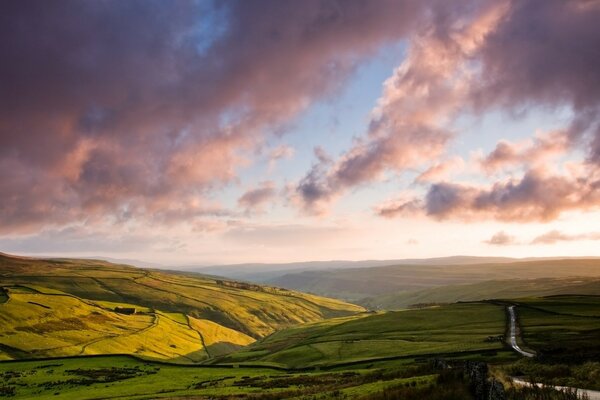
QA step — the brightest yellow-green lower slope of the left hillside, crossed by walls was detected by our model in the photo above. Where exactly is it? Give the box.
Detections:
[0,290,207,362]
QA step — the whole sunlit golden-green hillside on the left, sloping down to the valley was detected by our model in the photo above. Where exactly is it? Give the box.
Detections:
[0,255,363,362]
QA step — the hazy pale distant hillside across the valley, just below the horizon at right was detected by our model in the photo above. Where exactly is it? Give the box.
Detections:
[269,259,600,301]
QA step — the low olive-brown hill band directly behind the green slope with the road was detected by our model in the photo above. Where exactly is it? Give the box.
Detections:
[358,278,600,310]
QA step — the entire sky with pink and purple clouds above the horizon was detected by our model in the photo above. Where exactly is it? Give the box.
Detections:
[0,0,600,266]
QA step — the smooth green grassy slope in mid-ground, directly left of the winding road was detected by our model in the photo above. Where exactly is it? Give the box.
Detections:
[222,303,505,367]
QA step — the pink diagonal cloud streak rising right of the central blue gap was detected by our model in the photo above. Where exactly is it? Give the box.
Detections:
[297,4,504,212]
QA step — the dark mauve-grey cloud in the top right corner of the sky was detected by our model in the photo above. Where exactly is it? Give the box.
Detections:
[470,0,600,164]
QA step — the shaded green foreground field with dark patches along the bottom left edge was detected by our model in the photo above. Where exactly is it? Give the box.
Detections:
[0,356,436,399]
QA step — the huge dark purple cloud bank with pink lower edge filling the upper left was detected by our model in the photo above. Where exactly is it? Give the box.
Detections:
[0,0,428,233]
